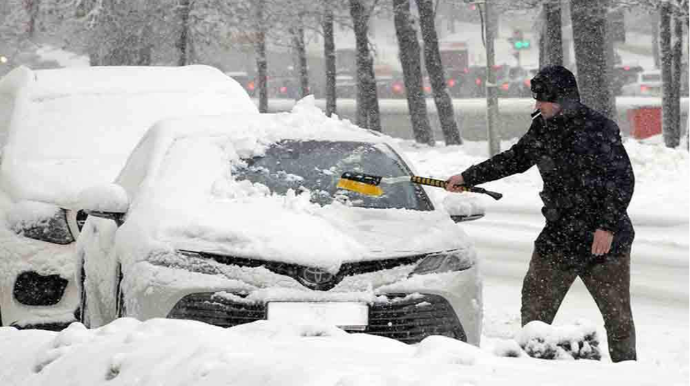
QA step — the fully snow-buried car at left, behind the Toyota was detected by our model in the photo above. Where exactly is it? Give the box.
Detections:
[0,66,258,329]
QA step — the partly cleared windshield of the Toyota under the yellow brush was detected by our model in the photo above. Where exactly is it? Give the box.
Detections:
[233,140,433,210]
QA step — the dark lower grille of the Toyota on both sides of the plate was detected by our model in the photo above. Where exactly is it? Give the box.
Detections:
[168,292,467,343]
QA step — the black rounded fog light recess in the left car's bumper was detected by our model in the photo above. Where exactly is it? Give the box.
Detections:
[13,271,67,306]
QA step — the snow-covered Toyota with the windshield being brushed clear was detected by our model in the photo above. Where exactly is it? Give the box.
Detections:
[77,97,483,345]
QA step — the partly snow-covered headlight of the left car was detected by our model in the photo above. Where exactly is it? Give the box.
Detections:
[7,201,74,245]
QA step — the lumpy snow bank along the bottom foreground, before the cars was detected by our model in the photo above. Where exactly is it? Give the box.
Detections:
[0,318,682,386]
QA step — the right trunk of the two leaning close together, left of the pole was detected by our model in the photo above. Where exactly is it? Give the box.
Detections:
[416,0,462,145]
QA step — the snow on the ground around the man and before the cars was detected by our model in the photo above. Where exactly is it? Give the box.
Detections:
[0,131,690,386]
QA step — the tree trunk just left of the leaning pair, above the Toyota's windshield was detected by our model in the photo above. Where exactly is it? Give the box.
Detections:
[350,0,381,131]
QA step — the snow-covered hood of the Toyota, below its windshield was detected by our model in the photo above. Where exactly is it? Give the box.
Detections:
[122,197,469,271]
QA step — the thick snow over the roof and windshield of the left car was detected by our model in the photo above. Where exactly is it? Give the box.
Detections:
[0,66,258,206]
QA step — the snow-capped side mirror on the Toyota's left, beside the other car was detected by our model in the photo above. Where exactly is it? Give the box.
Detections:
[79,184,129,226]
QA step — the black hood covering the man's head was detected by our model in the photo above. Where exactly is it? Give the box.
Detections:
[530,66,580,104]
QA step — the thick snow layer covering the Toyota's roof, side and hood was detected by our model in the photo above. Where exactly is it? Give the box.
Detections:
[113,97,468,272]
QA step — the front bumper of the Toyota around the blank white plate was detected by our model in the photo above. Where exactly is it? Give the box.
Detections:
[123,262,482,346]
